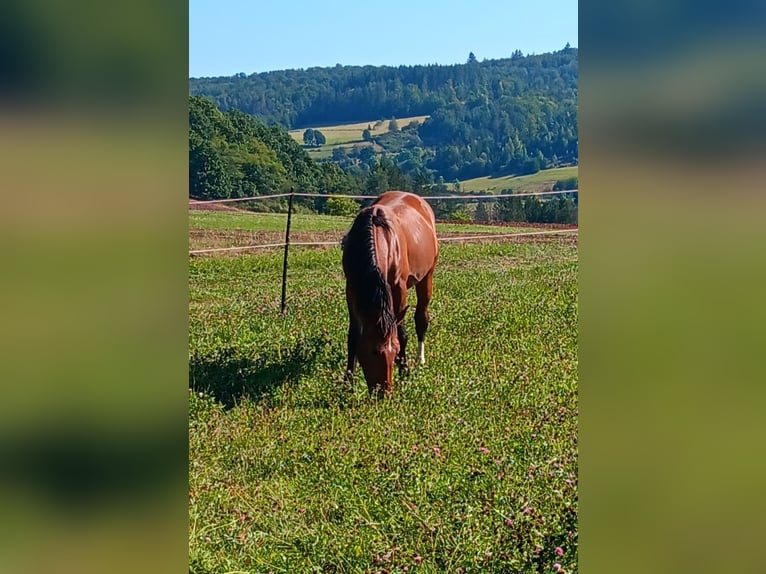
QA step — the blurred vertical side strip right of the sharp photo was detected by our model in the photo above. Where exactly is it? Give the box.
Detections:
[579,0,766,572]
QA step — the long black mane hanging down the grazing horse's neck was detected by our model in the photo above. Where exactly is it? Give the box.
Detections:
[343,205,396,338]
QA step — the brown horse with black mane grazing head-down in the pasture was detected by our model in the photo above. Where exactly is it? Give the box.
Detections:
[343,191,439,397]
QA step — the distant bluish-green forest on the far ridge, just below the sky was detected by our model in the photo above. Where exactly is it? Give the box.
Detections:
[190,45,578,181]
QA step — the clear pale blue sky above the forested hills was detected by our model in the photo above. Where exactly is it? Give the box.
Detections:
[189,0,578,77]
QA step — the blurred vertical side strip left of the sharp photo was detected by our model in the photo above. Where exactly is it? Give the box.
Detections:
[0,0,188,572]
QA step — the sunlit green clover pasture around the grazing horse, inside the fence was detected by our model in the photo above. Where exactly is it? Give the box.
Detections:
[189,217,578,573]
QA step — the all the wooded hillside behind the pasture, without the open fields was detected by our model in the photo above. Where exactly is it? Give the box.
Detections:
[189,46,577,223]
